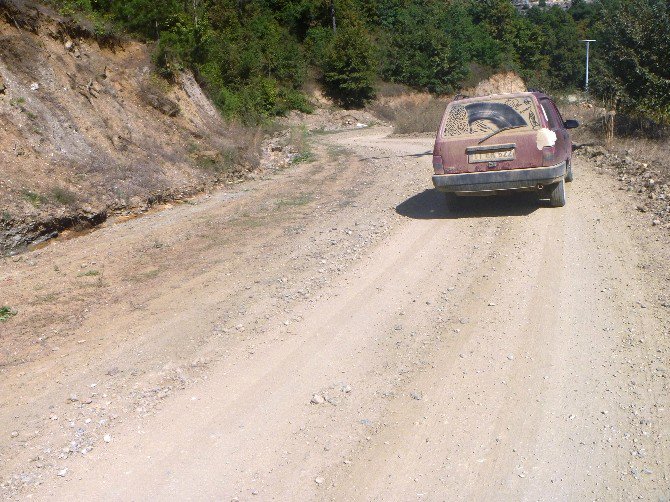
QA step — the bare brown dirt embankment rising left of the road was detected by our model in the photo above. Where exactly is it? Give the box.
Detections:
[0,0,261,253]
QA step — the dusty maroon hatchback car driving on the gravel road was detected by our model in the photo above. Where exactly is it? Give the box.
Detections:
[433,92,579,207]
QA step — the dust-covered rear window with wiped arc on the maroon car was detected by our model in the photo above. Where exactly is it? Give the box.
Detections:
[442,97,540,138]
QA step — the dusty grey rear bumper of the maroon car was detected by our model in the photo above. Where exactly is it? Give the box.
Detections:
[433,162,565,192]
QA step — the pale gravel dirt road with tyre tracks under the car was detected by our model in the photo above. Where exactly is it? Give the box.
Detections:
[0,128,670,501]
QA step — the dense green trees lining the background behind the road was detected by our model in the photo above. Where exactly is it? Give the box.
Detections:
[53,0,670,124]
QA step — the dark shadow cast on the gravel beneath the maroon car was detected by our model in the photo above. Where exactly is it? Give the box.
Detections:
[395,190,546,220]
